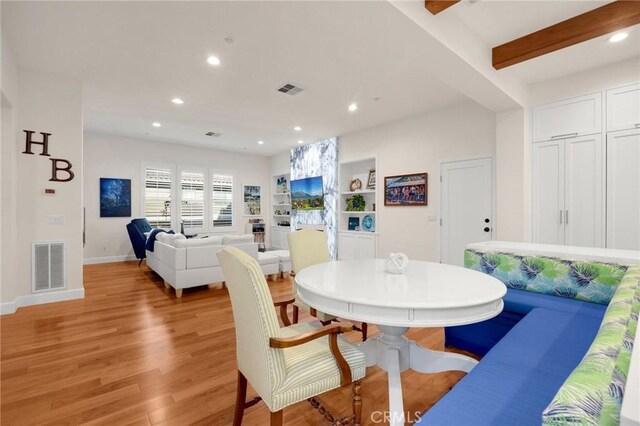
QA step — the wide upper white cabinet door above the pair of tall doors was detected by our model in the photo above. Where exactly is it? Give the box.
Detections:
[532,93,602,141]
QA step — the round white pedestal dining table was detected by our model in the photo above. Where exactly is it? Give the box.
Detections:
[295,259,507,426]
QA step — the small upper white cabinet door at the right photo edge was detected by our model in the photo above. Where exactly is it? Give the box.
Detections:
[607,83,640,132]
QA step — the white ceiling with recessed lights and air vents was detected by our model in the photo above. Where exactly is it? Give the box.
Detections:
[1,0,640,155]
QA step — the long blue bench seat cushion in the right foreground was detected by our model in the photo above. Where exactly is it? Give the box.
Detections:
[421,308,600,426]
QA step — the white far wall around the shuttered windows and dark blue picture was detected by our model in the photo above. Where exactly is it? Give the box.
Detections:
[84,132,271,263]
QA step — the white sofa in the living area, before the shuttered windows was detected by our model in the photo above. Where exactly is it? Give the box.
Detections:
[147,233,280,298]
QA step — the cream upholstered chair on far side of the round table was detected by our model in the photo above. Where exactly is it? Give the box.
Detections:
[287,229,368,342]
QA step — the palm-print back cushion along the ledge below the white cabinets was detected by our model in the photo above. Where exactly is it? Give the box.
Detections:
[464,250,627,305]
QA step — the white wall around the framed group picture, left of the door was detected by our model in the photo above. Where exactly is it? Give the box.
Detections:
[338,102,496,261]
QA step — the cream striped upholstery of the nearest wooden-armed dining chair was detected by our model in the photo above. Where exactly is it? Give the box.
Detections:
[218,247,365,422]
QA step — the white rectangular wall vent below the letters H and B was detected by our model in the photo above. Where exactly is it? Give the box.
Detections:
[31,241,67,292]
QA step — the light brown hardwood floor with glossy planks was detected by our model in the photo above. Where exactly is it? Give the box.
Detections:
[0,262,476,426]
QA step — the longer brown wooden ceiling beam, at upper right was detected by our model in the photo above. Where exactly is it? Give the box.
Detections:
[493,0,640,70]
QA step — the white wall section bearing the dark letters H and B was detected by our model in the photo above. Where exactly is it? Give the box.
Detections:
[2,68,84,313]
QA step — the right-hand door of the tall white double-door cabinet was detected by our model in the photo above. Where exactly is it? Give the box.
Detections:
[564,135,603,247]
